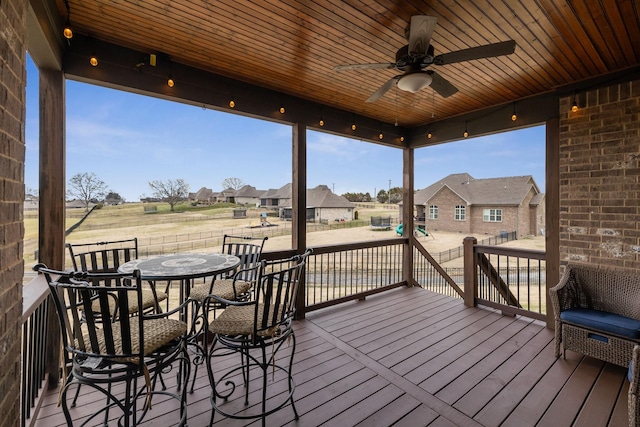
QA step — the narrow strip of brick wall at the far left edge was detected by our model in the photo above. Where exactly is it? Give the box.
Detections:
[0,0,28,426]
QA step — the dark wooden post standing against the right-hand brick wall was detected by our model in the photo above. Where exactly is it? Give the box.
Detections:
[544,116,560,328]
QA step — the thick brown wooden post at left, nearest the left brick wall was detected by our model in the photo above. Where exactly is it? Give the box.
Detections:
[38,69,66,387]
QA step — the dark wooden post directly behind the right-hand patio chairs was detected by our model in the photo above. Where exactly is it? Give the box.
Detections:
[291,123,307,319]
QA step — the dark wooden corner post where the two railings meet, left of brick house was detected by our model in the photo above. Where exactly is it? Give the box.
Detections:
[402,142,416,286]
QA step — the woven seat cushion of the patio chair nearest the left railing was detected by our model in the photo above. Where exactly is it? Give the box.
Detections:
[76,318,187,363]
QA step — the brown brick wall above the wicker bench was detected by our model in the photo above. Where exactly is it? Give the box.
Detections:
[559,80,640,271]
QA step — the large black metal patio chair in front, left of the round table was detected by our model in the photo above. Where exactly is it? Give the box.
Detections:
[34,264,190,426]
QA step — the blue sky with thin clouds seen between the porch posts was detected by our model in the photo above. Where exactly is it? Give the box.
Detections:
[25,59,545,202]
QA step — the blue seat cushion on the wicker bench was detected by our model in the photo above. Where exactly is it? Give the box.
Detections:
[560,308,640,339]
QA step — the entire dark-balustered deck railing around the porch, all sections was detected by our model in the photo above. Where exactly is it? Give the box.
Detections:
[21,237,546,425]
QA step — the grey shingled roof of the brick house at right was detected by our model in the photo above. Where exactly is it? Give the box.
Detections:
[414,173,540,206]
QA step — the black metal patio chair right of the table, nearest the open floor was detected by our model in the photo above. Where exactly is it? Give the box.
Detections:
[203,250,311,426]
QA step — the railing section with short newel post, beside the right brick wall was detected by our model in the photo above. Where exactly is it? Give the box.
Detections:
[464,238,547,320]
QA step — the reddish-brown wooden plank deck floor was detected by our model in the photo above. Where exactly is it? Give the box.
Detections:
[35,288,628,427]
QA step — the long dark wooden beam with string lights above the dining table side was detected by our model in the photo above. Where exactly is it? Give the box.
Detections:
[63,35,408,148]
